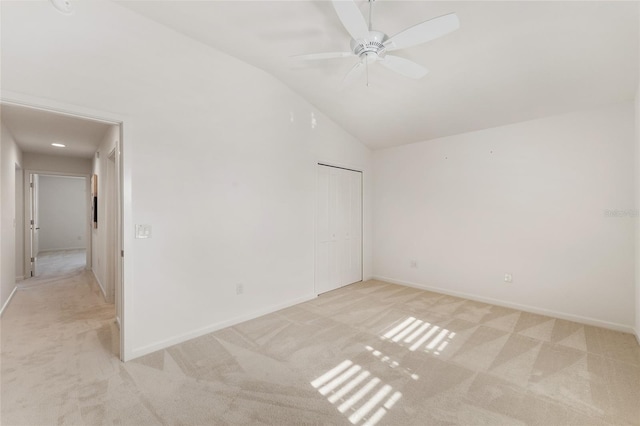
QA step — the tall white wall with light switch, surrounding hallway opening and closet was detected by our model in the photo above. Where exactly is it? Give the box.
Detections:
[1,2,372,358]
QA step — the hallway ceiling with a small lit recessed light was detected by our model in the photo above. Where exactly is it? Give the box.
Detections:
[0,104,111,158]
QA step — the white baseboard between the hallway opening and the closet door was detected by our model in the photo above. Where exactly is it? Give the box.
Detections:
[127,294,318,361]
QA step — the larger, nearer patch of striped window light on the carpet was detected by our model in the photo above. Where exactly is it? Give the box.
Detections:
[311,360,402,426]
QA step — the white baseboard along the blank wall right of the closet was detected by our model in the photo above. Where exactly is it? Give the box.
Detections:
[373,275,640,334]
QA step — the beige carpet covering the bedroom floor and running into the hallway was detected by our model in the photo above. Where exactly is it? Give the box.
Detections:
[1,271,640,426]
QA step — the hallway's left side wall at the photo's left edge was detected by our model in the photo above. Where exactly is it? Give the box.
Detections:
[0,123,22,309]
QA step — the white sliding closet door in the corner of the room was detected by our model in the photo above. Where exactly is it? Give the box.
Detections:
[316,165,362,294]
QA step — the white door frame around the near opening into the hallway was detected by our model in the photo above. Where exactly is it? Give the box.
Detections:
[0,90,134,361]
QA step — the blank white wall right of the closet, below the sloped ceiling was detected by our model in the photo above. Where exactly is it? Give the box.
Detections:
[374,102,636,331]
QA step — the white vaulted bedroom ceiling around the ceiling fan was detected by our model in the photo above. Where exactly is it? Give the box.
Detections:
[119,0,639,149]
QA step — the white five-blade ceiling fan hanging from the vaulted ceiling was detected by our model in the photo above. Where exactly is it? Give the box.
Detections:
[294,0,460,86]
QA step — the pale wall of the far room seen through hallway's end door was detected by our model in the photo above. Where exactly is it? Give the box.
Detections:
[38,175,89,252]
